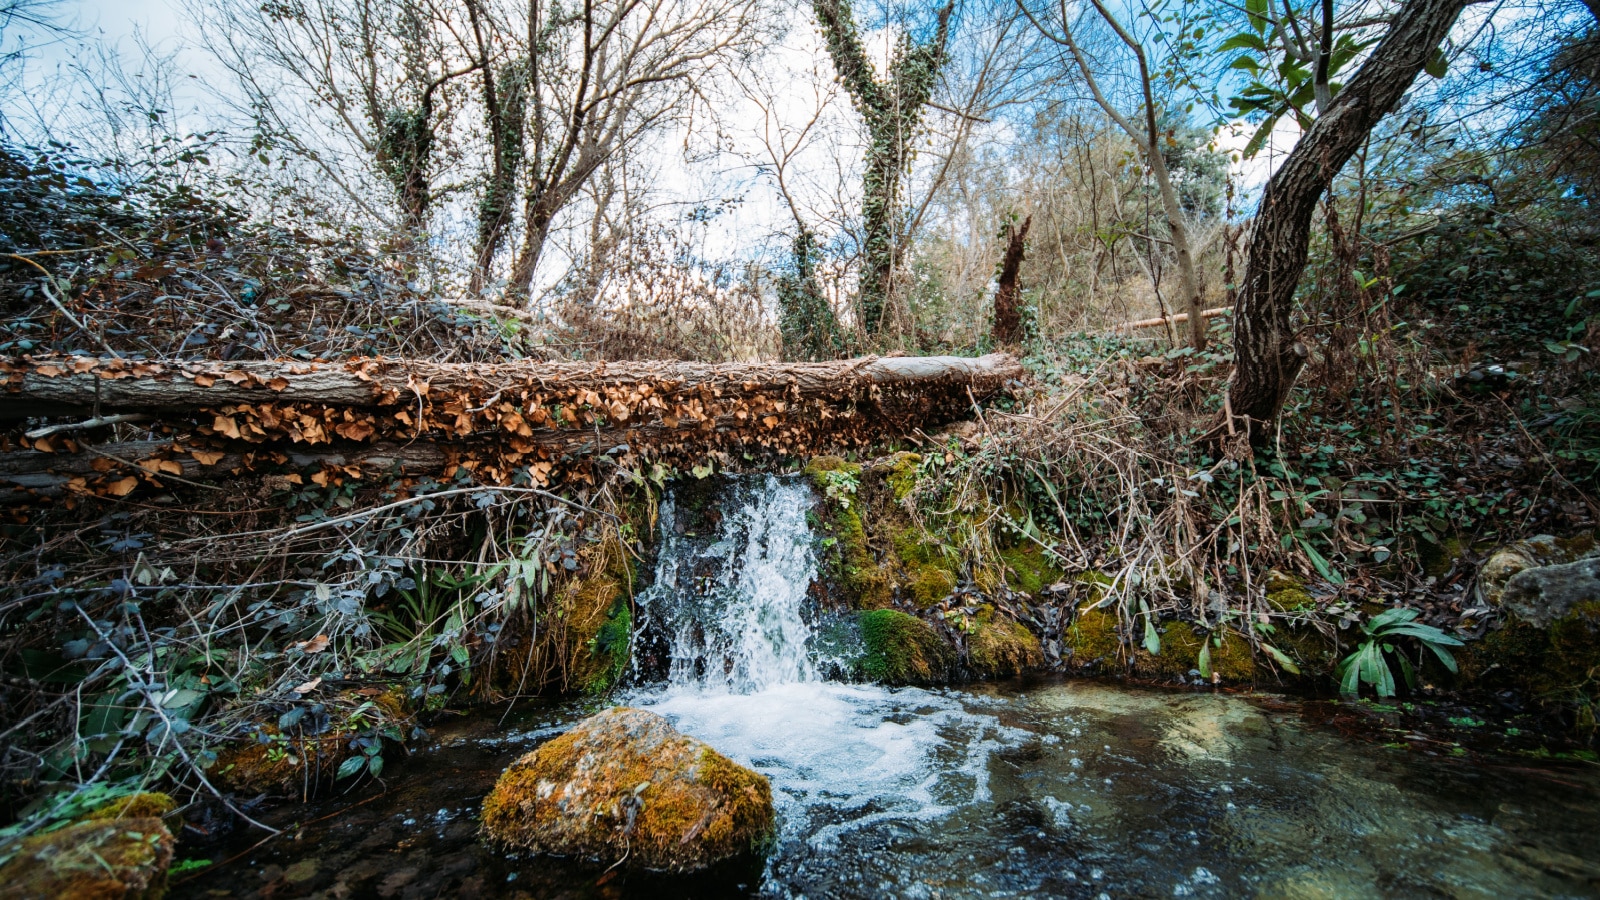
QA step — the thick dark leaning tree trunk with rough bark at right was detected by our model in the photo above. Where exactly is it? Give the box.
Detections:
[1229,0,1470,436]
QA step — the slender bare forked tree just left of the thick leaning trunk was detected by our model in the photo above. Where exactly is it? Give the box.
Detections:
[1018,0,1206,349]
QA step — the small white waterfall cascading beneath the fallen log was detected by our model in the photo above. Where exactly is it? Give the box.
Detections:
[635,476,819,693]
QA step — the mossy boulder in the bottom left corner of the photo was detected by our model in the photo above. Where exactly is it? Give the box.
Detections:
[0,817,173,900]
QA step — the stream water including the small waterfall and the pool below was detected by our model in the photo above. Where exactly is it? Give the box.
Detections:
[174,479,1600,898]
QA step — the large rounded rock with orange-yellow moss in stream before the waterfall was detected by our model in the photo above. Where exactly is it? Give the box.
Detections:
[483,706,776,873]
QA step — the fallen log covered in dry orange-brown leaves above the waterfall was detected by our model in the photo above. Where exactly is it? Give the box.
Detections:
[0,354,1022,503]
